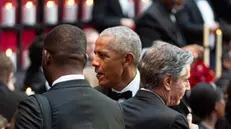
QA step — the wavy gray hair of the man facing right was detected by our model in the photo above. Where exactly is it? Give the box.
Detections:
[138,41,194,90]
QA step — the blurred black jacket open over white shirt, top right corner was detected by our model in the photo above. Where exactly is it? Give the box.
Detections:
[176,0,231,45]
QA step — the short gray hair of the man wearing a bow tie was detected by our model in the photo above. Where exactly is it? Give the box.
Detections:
[100,26,142,65]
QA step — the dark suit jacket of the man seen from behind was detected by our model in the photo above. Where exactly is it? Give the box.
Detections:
[15,80,124,129]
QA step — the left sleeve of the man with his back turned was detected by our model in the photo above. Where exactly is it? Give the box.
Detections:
[15,96,43,129]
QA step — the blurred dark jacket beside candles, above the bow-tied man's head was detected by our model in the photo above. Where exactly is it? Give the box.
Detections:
[92,0,128,32]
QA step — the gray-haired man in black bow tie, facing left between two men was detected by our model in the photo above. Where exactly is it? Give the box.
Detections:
[92,26,142,102]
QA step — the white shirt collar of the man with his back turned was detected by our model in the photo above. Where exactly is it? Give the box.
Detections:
[52,74,85,86]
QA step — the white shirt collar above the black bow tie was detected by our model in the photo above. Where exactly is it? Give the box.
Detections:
[112,70,140,97]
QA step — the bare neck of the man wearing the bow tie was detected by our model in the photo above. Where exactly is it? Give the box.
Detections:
[113,68,136,91]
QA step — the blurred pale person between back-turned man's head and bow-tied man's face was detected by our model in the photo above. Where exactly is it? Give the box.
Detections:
[83,28,99,87]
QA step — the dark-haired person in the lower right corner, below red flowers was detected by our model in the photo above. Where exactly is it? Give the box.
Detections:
[189,83,226,129]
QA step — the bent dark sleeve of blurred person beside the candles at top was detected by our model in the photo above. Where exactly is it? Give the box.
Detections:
[92,0,121,27]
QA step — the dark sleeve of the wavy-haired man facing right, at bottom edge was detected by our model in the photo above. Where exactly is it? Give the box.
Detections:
[170,115,189,129]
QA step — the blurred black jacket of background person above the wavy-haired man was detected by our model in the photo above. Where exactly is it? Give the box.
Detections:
[136,0,186,47]
